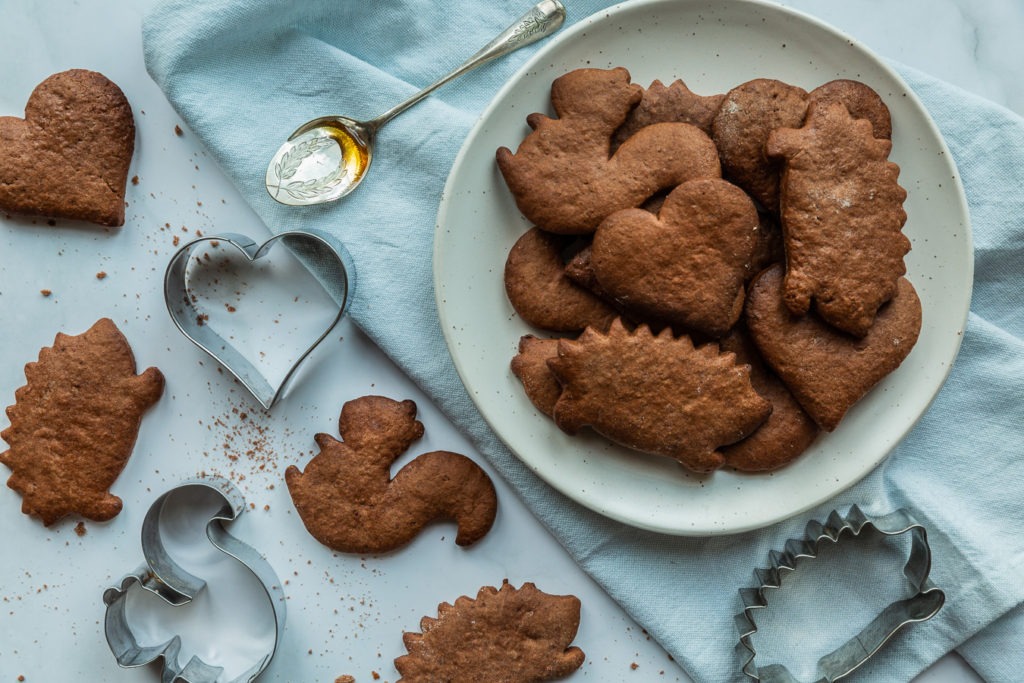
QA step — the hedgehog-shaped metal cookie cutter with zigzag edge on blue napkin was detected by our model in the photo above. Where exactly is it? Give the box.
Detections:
[735,505,945,683]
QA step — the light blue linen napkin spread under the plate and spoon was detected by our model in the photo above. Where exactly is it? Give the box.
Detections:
[143,0,1024,681]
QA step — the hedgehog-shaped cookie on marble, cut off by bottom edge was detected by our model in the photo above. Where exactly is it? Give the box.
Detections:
[394,581,585,683]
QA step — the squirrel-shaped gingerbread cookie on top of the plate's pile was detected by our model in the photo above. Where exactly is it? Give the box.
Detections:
[497,68,721,234]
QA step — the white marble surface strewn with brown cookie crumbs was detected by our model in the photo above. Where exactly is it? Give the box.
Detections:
[0,0,1024,683]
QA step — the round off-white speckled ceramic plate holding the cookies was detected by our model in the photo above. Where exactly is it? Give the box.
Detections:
[434,0,973,536]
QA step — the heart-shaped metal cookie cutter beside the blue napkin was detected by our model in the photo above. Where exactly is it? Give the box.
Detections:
[164,230,355,410]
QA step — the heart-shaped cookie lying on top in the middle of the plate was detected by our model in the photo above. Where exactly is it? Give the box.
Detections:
[592,178,758,337]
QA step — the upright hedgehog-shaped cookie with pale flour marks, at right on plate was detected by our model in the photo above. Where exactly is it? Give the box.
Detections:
[765,102,910,336]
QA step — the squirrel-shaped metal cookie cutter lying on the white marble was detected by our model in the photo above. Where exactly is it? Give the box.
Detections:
[103,477,286,683]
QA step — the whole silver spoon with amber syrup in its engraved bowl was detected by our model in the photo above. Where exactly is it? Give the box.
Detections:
[266,0,565,206]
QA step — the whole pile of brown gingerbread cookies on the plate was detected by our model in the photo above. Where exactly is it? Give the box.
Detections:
[497,68,922,472]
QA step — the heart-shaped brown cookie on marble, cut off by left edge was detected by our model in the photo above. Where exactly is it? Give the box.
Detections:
[0,69,135,226]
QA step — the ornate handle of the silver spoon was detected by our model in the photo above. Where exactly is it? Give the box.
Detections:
[366,0,565,131]
